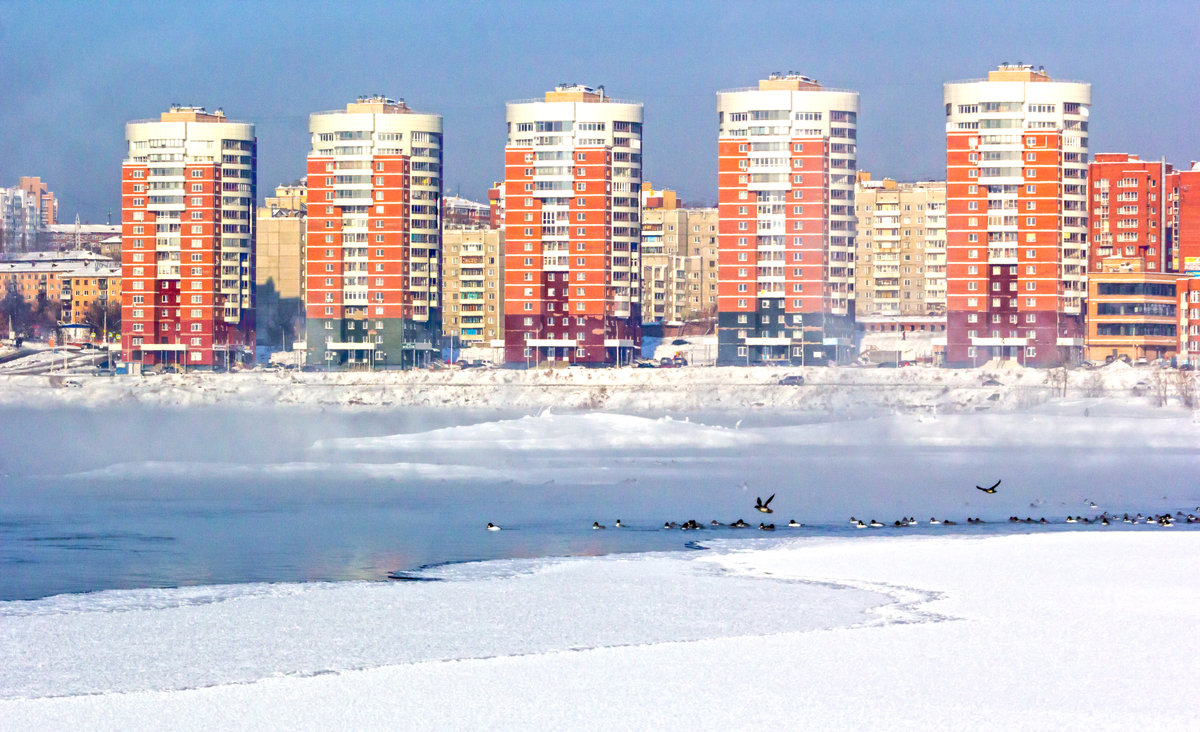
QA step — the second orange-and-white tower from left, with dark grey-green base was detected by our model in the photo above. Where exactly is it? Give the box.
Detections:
[305,96,442,367]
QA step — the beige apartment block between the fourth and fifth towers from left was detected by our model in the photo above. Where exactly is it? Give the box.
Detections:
[854,172,946,317]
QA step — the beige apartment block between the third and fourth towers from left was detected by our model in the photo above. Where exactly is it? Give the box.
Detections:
[642,208,716,323]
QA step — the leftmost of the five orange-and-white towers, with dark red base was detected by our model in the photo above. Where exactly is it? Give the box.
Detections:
[121,106,258,367]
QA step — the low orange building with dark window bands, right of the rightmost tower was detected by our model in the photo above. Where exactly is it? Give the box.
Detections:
[1087,256,1178,361]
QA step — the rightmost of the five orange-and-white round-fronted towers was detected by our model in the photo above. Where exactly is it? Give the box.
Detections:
[943,64,1091,366]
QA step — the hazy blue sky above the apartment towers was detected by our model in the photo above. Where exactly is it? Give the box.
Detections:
[0,0,1200,222]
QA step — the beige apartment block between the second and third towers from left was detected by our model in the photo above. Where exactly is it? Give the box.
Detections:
[442,229,504,348]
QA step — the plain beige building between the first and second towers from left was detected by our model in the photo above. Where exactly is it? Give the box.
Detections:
[254,181,306,346]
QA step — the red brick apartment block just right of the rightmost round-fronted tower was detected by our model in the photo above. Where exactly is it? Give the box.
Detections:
[1087,152,1174,272]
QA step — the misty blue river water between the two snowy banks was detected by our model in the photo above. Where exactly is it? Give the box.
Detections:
[0,408,1200,600]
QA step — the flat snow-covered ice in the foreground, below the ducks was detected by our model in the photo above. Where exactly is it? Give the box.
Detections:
[0,527,1200,730]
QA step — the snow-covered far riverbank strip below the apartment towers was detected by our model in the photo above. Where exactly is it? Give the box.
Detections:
[0,364,1200,413]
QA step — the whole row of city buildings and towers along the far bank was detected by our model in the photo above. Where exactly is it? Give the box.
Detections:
[0,64,1200,372]
